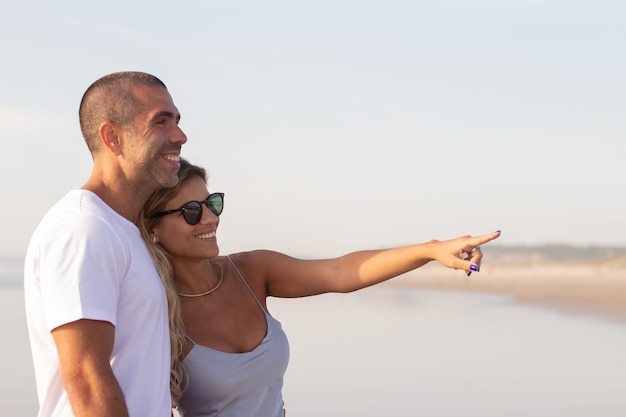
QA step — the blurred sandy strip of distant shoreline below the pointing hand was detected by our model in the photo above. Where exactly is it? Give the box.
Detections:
[390,261,626,322]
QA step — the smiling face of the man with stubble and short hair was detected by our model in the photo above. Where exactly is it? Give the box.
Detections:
[122,86,187,192]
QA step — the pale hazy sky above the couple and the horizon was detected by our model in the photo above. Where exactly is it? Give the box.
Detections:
[0,0,626,256]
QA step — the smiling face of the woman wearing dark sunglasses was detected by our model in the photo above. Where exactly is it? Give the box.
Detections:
[152,176,220,261]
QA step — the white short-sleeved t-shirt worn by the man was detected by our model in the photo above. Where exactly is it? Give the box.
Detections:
[24,190,171,417]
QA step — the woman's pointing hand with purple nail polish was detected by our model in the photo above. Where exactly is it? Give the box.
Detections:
[429,230,500,276]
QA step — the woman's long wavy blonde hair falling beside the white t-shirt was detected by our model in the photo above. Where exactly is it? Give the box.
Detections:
[137,158,207,406]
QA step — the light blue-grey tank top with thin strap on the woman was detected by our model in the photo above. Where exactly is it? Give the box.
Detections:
[180,256,289,417]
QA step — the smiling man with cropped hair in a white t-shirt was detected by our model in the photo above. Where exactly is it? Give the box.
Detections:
[24,72,187,417]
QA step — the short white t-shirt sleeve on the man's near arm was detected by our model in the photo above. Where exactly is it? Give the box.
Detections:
[40,211,127,331]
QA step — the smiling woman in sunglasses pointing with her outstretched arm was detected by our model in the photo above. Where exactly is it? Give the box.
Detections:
[139,159,500,417]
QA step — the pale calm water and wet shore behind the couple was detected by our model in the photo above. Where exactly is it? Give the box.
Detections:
[0,255,626,417]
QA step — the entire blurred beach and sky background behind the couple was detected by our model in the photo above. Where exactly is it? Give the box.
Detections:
[0,0,626,417]
